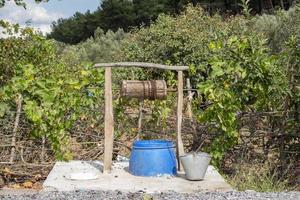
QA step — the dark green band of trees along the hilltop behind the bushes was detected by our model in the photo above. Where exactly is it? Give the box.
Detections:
[49,0,298,44]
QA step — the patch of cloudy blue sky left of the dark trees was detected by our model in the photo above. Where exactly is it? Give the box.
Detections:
[0,0,100,33]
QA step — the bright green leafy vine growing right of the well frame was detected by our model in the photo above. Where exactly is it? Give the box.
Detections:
[198,35,286,166]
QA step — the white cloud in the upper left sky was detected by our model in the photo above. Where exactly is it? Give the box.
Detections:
[0,1,65,33]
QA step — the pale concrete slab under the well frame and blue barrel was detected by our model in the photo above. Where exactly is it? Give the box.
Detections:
[43,161,233,193]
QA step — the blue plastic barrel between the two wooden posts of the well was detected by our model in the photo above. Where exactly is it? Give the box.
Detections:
[129,140,177,176]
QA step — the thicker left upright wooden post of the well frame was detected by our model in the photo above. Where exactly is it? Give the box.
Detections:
[103,67,114,173]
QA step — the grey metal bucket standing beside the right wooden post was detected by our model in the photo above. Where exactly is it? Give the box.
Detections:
[180,152,211,181]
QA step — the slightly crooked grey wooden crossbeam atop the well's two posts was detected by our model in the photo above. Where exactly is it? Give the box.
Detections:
[94,62,189,71]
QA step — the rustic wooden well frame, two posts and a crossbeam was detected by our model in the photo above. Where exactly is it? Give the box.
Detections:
[94,62,188,173]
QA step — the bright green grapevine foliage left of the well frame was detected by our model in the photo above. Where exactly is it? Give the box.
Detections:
[0,21,103,159]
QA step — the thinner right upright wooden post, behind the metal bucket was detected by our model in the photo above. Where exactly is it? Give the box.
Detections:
[176,71,184,171]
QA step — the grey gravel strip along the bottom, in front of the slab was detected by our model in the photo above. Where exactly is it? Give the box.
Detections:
[0,191,300,200]
